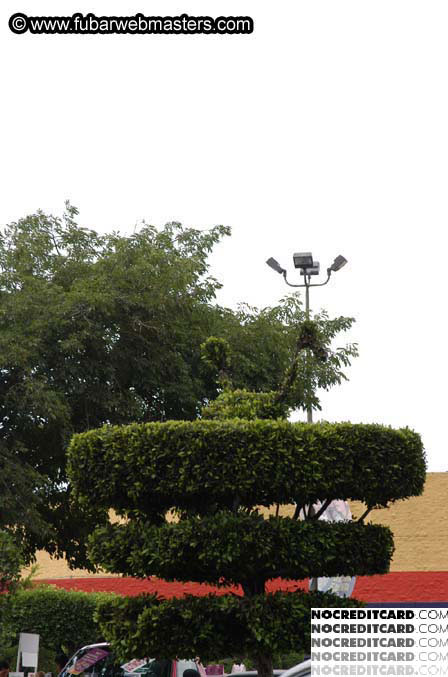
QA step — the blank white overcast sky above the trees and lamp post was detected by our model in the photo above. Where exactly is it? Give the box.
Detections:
[0,0,448,471]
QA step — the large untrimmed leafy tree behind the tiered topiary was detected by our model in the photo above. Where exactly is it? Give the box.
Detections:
[0,204,356,567]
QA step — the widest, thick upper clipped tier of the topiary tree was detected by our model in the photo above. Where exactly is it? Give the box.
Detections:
[69,419,425,516]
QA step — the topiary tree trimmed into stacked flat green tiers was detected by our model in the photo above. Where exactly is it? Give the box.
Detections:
[69,378,425,677]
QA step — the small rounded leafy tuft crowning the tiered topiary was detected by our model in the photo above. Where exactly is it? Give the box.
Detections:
[201,390,289,420]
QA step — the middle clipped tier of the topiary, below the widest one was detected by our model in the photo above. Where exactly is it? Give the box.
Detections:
[86,511,394,589]
